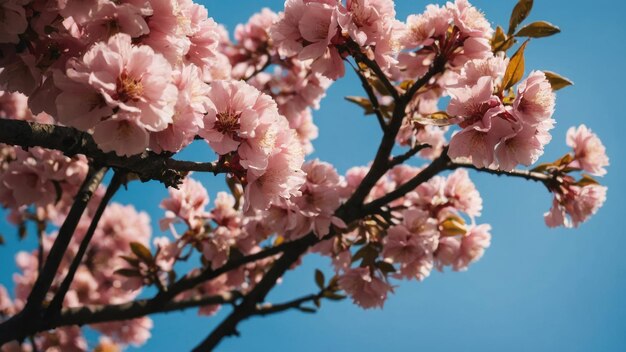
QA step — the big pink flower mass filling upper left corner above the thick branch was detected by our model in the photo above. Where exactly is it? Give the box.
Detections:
[0,0,230,155]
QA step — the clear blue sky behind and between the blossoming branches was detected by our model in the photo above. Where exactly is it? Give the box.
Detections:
[0,0,626,352]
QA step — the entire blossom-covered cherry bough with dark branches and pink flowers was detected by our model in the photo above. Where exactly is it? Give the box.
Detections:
[0,0,609,351]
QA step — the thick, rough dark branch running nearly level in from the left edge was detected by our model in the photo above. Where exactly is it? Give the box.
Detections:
[0,119,226,187]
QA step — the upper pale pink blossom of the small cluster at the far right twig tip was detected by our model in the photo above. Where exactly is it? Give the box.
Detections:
[567,125,609,176]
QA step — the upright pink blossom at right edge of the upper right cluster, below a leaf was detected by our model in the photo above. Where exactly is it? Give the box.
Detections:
[513,71,556,126]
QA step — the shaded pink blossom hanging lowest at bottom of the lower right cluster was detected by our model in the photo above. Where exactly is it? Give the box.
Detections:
[339,268,393,309]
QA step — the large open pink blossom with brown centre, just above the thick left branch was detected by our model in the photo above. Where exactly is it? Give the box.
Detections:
[57,34,177,155]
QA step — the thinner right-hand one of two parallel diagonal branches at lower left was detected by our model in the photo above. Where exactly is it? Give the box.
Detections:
[46,172,124,320]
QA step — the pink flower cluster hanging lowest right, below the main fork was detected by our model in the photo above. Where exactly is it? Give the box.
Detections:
[326,166,491,308]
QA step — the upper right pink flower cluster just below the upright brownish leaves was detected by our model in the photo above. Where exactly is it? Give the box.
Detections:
[447,63,555,170]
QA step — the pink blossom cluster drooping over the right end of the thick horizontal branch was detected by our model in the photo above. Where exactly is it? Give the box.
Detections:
[199,81,304,210]
